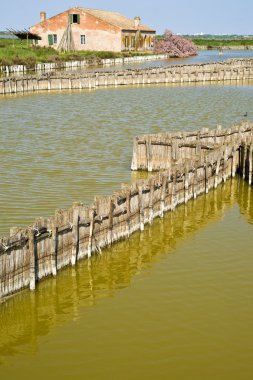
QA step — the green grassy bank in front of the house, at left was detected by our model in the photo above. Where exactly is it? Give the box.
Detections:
[0,38,150,68]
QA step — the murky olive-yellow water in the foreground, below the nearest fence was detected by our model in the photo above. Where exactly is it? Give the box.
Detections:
[0,180,253,380]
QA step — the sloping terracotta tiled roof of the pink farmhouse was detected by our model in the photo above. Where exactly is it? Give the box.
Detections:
[75,7,155,32]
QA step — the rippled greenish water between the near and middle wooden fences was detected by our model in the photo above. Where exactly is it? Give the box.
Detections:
[0,84,253,236]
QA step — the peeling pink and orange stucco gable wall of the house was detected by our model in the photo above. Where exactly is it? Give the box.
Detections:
[30,8,121,51]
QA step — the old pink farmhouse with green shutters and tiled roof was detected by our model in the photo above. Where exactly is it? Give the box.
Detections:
[30,7,156,52]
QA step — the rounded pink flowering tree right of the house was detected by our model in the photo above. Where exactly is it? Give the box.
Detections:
[154,30,198,58]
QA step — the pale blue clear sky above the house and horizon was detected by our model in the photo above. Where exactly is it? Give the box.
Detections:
[0,0,253,34]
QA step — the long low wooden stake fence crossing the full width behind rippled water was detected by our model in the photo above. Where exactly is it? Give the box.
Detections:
[0,59,253,95]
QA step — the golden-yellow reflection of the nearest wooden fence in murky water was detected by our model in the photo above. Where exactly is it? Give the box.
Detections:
[0,180,253,364]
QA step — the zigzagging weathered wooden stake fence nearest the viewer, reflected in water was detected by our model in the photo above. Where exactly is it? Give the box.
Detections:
[0,123,253,297]
